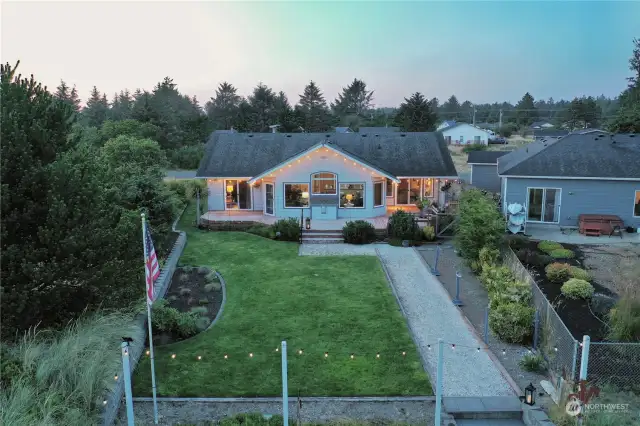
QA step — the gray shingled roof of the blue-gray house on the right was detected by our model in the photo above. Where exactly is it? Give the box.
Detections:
[498,132,640,180]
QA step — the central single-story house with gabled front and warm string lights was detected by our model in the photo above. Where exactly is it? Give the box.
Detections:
[197,132,457,220]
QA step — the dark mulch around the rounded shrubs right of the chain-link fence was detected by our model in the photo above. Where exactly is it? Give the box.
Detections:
[525,240,617,341]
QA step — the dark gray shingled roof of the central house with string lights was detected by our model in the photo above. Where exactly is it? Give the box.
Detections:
[197,132,457,177]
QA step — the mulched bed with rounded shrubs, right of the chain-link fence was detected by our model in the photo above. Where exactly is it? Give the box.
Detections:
[512,240,617,341]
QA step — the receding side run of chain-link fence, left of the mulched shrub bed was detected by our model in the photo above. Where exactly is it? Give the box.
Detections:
[503,249,580,380]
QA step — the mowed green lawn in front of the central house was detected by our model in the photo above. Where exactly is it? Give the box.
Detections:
[133,206,432,397]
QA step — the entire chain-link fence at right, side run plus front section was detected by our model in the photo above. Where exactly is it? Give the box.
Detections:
[503,248,640,389]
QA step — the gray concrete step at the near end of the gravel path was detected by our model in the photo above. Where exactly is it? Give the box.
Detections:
[442,396,522,424]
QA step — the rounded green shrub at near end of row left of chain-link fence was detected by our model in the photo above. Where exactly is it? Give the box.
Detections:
[489,303,534,343]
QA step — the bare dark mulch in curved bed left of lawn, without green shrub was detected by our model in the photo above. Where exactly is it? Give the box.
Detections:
[153,266,222,345]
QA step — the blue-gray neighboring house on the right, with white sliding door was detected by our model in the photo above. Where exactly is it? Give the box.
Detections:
[498,132,640,227]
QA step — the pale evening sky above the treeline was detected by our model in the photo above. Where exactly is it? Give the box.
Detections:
[0,0,640,106]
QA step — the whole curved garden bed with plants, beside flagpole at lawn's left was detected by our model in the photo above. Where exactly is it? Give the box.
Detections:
[152,266,225,345]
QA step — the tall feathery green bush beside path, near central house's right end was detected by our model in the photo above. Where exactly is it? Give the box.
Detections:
[455,189,505,261]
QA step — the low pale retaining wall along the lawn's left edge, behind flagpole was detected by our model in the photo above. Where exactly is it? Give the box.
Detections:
[101,204,189,426]
